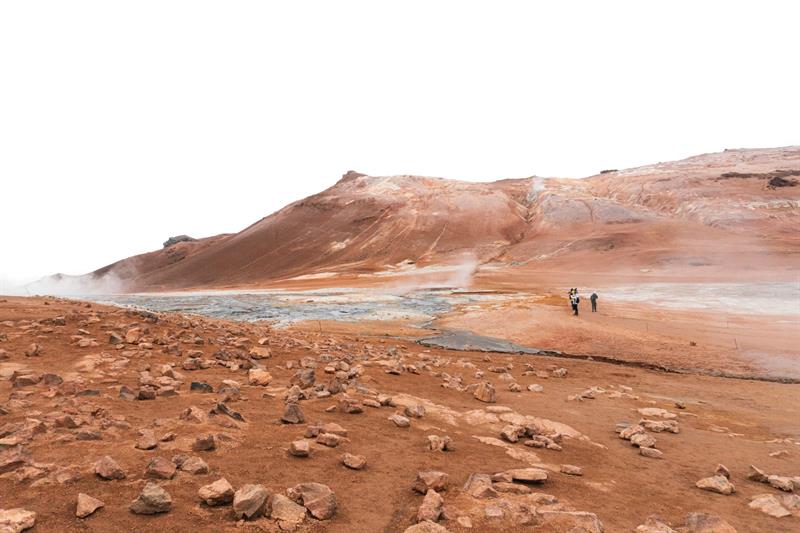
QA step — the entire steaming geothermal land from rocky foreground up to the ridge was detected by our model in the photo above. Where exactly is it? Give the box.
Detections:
[0,147,800,533]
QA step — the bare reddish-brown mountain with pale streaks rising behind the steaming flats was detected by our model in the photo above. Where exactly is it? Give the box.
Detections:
[76,146,800,291]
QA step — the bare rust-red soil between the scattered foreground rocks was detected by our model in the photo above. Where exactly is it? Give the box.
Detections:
[0,298,800,532]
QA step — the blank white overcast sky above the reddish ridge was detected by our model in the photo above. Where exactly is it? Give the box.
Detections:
[0,0,800,286]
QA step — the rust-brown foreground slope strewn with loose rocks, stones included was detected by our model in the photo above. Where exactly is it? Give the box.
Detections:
[0,298,800,533]
